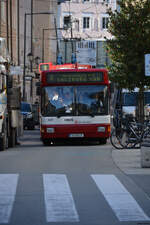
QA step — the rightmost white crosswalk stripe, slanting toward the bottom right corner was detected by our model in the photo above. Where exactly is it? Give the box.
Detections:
[91,175,150,221]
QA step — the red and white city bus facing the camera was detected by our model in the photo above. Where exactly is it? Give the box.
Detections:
[40,63,110,145]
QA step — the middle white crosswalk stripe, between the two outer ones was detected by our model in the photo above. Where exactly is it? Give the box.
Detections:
[43,174,79,222]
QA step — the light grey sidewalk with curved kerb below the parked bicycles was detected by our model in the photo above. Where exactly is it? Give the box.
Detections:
[111,146,150,175]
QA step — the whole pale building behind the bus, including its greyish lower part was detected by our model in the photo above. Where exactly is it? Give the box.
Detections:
[57,0,117,66]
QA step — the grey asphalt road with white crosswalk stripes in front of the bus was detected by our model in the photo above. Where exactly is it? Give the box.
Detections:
[0,130,150,225]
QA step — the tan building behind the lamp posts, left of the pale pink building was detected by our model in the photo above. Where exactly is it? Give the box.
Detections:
[19,0,57,103]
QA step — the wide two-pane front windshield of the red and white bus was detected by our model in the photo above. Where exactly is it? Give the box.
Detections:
[41,85,109,117]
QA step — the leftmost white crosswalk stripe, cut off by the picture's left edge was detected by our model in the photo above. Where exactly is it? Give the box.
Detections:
[0,174,19,223]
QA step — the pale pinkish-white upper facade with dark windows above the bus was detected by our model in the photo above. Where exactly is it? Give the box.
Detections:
[58,0,117,40]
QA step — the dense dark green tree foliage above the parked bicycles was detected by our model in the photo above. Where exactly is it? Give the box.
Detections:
[106,0,150,90]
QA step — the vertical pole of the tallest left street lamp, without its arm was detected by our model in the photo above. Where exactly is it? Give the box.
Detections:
[23,13,27,101]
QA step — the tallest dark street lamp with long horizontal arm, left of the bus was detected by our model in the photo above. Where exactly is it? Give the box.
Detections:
[23,12,54,101]
